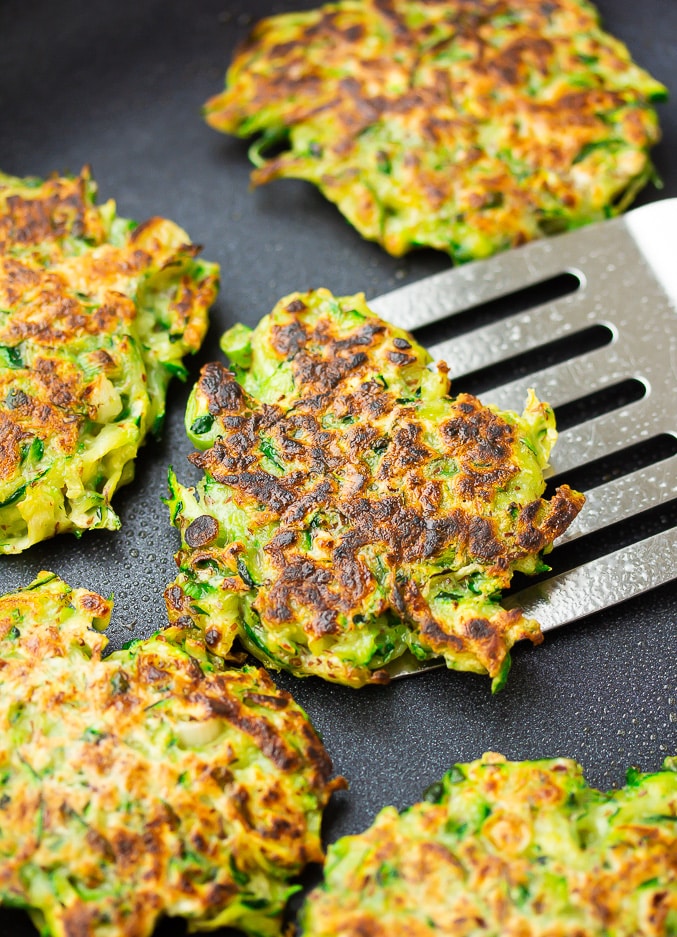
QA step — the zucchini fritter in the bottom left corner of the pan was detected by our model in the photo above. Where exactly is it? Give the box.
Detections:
[0,573,342,937]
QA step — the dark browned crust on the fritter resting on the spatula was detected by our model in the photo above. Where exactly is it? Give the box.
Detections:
[182,301,583,675]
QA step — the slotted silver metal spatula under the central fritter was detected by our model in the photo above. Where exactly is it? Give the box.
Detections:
[370,199,677,676]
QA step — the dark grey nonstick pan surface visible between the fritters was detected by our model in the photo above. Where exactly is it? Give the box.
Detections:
[0,0,677,937]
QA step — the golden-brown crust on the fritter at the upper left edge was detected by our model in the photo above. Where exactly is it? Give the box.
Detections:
[0,169,215,481]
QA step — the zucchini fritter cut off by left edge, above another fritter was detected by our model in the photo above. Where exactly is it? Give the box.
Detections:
[0,169,218,553]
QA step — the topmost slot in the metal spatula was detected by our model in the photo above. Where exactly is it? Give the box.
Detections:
[406,272,581,347]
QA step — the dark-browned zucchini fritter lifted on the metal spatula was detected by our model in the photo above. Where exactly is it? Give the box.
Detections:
[166,290,583,689]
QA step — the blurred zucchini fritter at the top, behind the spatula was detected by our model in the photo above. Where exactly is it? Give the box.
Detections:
[206,0,666,261]
